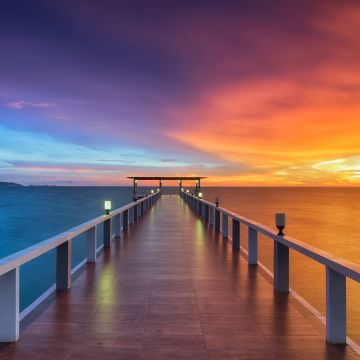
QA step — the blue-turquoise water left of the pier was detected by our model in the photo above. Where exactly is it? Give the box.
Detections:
[0,186,139,310]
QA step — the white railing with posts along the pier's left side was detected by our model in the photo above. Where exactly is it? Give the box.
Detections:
[0,192,161,342]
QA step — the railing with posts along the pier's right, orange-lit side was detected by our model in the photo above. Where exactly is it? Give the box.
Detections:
[180,192,360,344]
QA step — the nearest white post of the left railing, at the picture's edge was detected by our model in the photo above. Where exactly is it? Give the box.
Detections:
[0,268,19,342]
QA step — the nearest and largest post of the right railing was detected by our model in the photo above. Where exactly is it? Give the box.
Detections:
[326,267,346,344]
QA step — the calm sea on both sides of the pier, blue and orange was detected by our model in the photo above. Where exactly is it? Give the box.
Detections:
[0,187,360,343]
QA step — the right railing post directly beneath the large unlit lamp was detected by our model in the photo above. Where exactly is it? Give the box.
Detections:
[274,240,289,293]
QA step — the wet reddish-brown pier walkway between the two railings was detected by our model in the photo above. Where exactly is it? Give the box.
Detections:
[0,196,358,360]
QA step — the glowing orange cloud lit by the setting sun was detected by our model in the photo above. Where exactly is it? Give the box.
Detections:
[167,68,360,184]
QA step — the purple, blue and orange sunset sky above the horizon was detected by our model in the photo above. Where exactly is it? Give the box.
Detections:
[0,0,360,186]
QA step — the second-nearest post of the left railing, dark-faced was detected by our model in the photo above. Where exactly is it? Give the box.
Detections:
[56,240,71,291]
